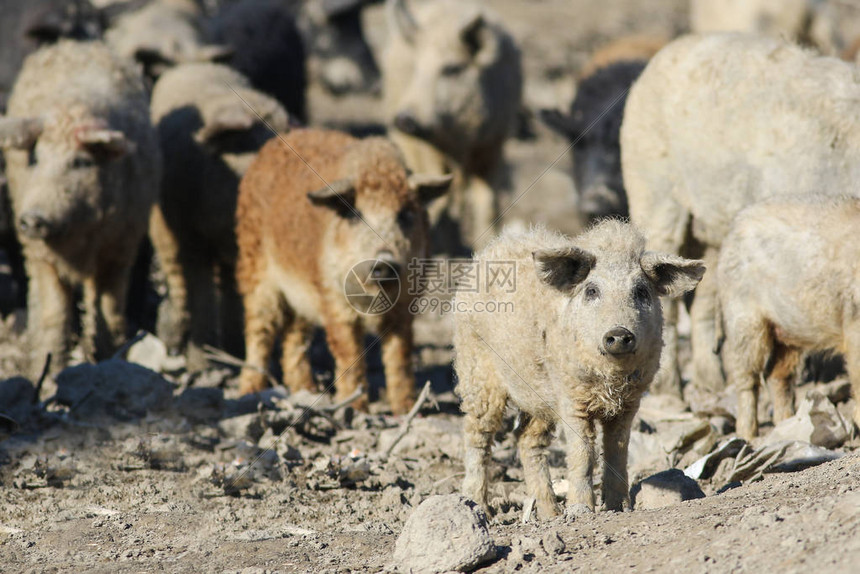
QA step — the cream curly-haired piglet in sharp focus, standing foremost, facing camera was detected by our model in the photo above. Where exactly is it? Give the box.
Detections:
[454,219,705,519]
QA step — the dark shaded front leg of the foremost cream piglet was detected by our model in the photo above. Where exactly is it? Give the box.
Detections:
[603,401,639,511]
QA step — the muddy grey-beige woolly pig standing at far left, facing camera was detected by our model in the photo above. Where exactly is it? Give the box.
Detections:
[0,40,161,374]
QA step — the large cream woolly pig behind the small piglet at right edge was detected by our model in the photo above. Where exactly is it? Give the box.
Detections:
[621,33,860,393]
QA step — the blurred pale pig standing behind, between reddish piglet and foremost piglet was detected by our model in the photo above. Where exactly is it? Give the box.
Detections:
[382,0,523,252]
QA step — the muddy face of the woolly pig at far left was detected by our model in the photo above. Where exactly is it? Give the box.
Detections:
[6,114,133,241]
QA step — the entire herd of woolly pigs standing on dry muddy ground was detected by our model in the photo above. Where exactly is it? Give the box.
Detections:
[0,0,860,517]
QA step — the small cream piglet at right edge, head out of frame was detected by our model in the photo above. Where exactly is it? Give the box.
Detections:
[717,195,860,440]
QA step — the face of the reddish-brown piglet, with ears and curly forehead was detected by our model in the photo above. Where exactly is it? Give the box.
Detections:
[309,142,451,318]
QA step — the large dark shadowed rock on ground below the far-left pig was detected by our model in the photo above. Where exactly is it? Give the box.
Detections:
[57,359,173,419]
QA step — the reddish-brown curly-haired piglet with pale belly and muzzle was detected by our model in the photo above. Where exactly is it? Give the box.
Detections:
[236,129,451,414]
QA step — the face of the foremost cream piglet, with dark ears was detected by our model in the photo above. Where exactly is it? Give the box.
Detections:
[534,234,704,388]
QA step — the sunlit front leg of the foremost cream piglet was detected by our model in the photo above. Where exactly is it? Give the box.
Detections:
[561,405,595,511]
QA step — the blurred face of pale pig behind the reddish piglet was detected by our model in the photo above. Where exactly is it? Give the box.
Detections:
[393,7,501,159]
